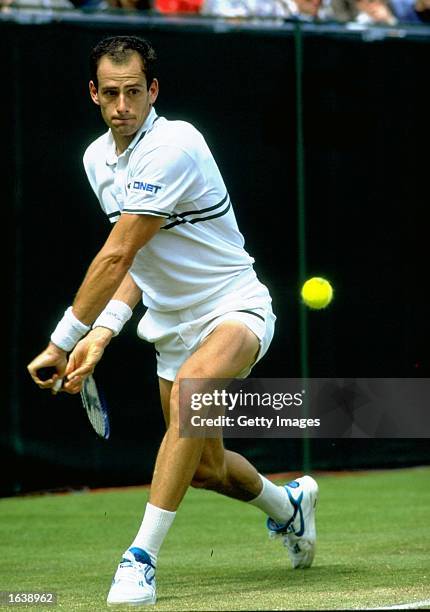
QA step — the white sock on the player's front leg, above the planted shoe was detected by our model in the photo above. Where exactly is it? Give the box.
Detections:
[130,502,176,565]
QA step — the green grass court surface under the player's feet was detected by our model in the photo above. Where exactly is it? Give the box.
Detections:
[0,468,430,612]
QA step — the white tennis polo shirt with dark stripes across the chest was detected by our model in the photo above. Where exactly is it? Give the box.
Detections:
[84,109,254,311]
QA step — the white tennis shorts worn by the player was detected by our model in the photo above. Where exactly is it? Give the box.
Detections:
[137,268,276,381]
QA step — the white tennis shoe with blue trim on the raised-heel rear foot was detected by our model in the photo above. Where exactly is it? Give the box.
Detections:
[267,476,318,569]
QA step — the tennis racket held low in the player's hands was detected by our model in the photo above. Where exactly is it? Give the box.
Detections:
[38,367,110,440]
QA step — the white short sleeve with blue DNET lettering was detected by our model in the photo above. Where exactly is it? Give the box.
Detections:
[123,145,203,218]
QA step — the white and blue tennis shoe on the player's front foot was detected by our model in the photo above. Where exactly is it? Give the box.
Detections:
[107,548,157,606]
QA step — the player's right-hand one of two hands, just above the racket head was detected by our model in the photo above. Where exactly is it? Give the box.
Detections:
[62,327,113,393]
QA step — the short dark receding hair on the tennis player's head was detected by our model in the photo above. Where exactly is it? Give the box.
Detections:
[90,36,157,89]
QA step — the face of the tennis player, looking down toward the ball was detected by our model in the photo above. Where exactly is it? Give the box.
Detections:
[90,53,158,149]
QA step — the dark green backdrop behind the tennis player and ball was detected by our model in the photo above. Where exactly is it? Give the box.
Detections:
[0,11,430,494]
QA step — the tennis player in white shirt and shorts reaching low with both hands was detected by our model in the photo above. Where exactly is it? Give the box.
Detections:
[28,36,318,605]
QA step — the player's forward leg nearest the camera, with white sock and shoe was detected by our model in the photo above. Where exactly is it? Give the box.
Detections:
[107,321,261,605]
